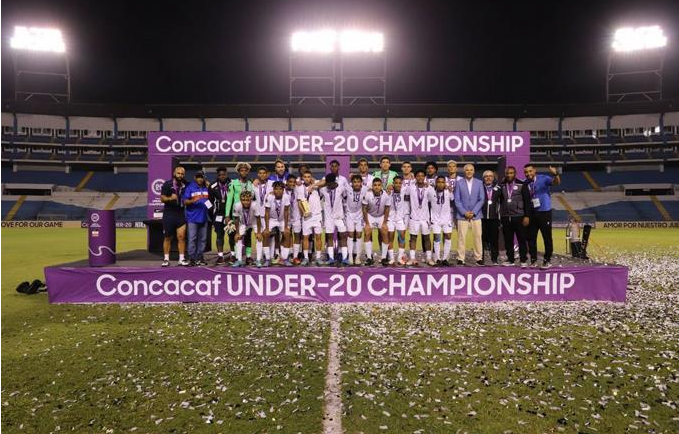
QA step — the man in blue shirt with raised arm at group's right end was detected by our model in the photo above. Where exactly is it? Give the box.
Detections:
[523,163,561,270]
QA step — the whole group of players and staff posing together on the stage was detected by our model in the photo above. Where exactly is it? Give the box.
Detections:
[161,157,561,269]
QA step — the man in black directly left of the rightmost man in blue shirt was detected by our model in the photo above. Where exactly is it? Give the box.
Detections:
[500,166,530,268]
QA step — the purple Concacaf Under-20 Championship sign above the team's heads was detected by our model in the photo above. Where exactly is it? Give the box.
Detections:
[148,131,530,156]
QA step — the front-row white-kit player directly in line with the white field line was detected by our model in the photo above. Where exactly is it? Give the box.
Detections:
[319,173,349,265]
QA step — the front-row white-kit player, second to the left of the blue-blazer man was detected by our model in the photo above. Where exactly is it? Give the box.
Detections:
[406,170,434,266]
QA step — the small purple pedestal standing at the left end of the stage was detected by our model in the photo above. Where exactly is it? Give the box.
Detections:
[87,210,116,267]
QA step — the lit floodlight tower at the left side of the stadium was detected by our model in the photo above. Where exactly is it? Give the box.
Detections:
[10,26,71,102]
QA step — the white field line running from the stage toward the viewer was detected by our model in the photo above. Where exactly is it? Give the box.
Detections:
[323,304,342,434]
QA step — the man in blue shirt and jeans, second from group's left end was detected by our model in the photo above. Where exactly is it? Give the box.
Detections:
[182,171,213,266]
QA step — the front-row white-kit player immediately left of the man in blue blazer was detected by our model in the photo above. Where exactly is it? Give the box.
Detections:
[427,175,453,267]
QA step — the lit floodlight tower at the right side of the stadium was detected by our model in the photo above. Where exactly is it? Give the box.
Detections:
[606,26,667,102]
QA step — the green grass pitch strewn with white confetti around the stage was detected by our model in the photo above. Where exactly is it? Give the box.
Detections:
[1,225,679,433]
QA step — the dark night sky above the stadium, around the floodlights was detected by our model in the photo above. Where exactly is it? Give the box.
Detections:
[2,0,679,104]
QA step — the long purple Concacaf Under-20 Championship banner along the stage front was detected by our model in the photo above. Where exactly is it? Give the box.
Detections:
[45,266,627,303]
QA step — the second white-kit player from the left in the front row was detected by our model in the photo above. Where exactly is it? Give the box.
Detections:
[262,181,292,267]
